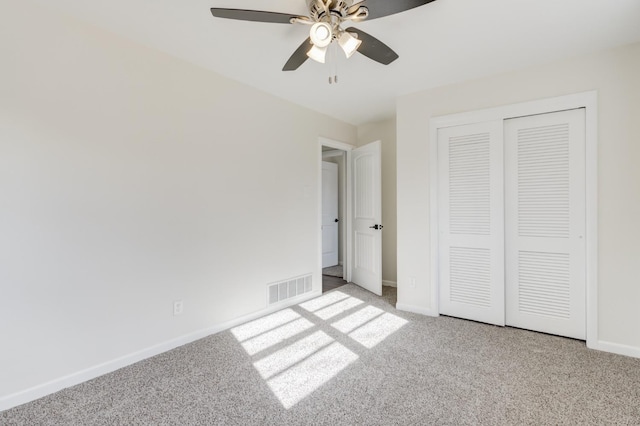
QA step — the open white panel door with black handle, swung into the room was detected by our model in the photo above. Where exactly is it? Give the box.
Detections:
[351,141,382,295]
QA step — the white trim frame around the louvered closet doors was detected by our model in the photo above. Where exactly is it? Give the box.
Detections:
[429,90,600,349]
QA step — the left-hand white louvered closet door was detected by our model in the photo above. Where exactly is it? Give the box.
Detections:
[438,121,505,325]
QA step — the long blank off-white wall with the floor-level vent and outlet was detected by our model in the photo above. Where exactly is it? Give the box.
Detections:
[0,0,356,409]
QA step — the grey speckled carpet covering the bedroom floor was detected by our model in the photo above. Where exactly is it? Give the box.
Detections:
[0,284,640,425]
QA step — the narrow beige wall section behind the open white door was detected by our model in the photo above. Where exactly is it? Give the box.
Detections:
[358,118,397,286]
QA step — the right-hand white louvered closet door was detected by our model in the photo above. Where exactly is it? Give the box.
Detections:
[504,109,586,339]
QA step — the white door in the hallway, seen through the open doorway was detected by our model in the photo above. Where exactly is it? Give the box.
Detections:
[322,161,338,268]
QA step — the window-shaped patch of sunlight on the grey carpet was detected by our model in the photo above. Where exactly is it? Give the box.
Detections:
[231,291,408,409]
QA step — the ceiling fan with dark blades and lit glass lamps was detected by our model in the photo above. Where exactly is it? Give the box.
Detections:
[211,0,434,71]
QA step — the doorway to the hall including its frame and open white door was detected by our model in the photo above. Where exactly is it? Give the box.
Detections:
[318,138,383,295]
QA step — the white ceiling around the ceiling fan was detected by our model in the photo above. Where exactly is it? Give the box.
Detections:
[40,0,640,124]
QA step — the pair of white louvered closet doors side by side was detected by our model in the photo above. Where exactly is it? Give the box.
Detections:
[437,108,586,339]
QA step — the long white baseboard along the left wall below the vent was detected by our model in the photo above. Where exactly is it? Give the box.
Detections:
[0,289,322,412]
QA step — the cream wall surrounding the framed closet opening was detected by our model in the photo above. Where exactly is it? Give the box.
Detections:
[397,44,640,356]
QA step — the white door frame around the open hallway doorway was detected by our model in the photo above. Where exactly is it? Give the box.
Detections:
[317,136,356,282]
